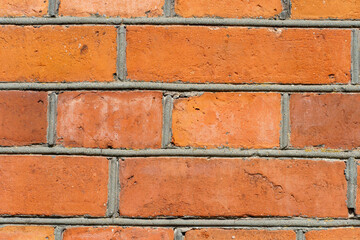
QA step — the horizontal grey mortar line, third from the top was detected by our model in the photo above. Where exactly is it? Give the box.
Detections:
[0,146,360,159]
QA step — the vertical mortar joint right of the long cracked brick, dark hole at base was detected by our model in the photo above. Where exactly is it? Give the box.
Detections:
[345,157,357,215]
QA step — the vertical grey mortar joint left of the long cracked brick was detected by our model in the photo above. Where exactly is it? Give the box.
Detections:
[106,158,119,217]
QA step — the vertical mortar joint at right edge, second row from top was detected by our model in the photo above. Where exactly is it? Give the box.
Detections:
[351,29,359,84]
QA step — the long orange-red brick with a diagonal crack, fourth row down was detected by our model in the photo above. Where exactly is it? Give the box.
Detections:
[120,158,348,217]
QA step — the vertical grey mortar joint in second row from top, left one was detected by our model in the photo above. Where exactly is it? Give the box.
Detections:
[116,25,127,81]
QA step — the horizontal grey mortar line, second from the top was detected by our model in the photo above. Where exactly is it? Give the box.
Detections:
[0,81,360,93]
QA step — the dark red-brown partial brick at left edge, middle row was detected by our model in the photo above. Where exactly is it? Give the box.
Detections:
[0,91,48,146]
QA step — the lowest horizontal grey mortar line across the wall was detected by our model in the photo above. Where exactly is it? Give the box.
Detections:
[0,217,360,228]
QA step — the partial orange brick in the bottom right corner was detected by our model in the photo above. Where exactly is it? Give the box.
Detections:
[305,228,360,240]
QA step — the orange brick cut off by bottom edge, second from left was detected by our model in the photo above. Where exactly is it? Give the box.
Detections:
[63,227,174,240]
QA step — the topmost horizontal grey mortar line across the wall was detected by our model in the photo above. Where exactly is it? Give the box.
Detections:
[0,17,360,28]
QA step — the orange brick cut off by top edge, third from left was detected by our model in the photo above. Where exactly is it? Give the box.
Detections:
[175,0,282,18]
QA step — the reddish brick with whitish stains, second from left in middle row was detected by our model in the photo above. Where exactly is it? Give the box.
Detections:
[57,92,162,149]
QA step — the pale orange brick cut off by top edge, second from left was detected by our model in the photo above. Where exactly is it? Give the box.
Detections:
[59,0,164,17]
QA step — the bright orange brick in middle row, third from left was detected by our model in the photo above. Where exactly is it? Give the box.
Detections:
[172,93,281,148]
